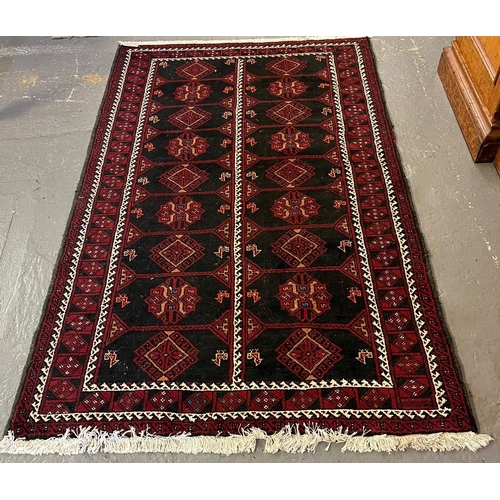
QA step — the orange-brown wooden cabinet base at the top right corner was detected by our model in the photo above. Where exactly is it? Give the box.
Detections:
[438,36,500,174]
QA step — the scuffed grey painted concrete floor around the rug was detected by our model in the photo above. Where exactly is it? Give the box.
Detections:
[0,37,500,463]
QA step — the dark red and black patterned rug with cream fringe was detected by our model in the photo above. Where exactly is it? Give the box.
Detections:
[0,38,490,454]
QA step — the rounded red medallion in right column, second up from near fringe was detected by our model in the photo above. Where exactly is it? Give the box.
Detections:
[276,273,332,322]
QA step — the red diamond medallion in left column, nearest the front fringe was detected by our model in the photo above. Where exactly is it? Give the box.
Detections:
[134,332,198,381]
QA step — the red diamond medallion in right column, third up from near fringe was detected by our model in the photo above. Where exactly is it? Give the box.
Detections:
[271,229,326,267]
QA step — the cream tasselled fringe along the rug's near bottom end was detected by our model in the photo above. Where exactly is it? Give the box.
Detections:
[0,426,493,455]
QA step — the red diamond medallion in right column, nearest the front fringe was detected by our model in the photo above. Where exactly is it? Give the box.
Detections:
[276,328,342,380]
